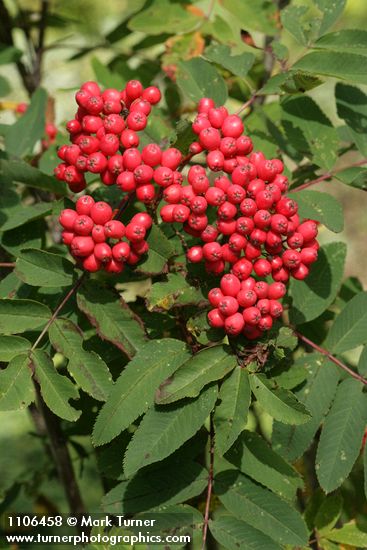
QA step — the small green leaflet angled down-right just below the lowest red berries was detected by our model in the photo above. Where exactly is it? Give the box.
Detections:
[250,374,310,424]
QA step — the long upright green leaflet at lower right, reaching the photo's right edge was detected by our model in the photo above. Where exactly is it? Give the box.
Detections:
[316,378,367,493]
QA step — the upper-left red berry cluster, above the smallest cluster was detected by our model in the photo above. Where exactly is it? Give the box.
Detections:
[55,80,162,195]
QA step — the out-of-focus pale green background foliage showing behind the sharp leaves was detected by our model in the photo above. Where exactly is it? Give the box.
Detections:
[0,0,367,544]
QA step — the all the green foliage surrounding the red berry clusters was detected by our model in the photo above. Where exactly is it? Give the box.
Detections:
[0,0,367,550]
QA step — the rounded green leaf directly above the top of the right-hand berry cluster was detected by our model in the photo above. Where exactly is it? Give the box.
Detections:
[177,57,228,105]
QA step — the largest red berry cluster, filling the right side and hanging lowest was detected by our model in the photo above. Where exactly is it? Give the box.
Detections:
[160,98,319,338]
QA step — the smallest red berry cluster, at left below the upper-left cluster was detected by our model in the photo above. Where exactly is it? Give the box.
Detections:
[59,195,152,273]
